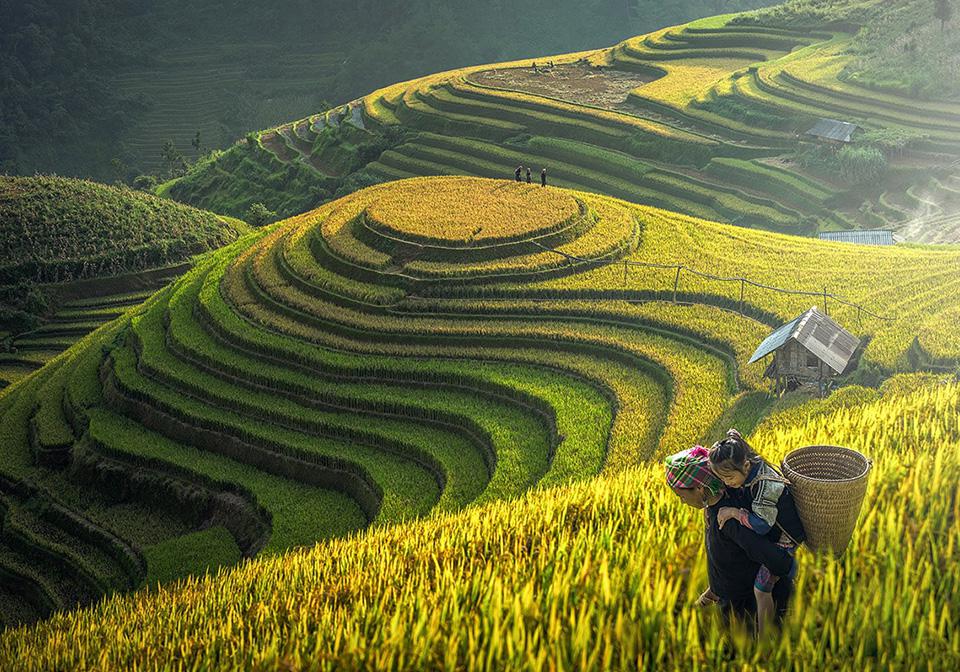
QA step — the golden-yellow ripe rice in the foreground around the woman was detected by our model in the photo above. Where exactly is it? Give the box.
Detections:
[0,382,960,670]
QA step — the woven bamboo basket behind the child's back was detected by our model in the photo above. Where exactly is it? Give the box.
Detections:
[782,446,873,557]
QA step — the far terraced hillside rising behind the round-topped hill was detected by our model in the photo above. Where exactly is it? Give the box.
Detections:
[164,3,960,242]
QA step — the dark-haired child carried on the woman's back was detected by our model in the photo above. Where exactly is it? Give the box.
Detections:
[710,429,806,633]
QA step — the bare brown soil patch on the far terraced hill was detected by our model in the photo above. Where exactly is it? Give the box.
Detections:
[468,62,657,110]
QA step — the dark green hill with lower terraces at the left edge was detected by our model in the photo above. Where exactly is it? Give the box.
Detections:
[0,177,247,392]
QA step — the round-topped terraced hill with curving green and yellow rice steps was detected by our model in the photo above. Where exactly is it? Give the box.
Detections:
[0,177,960,640]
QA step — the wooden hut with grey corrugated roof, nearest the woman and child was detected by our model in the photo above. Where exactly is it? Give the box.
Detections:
[750,307,860,394]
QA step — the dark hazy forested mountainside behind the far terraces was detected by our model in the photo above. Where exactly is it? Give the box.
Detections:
[0,0,771,181]
